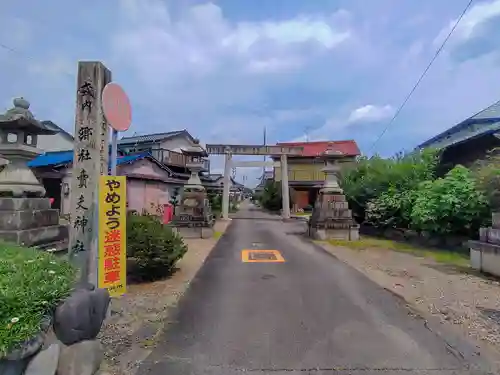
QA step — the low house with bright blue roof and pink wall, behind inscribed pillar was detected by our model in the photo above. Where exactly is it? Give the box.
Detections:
[28,151,217,216]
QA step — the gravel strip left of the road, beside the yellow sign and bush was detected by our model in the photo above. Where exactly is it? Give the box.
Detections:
[99,221,230,375]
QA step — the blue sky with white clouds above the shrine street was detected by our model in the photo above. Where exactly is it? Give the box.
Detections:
[0,0,500,185]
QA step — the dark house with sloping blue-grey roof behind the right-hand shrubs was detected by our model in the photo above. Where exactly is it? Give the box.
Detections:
[417,101,500,173]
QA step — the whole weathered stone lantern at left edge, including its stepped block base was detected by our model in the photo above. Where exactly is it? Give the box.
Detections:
[0,98,68,251]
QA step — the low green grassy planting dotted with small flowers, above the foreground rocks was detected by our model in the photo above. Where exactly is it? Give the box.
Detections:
[0,242,75,358]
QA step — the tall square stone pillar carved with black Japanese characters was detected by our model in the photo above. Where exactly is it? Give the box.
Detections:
[69,62,111,285]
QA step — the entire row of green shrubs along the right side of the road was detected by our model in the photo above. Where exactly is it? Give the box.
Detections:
[341,150,499,237]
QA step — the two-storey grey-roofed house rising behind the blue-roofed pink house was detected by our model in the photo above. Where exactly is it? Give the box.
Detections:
[118,129,210,172]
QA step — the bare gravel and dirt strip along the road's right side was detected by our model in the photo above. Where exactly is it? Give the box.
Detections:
[317,242,500,362]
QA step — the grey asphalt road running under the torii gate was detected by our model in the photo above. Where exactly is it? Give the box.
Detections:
[138,209,496,375]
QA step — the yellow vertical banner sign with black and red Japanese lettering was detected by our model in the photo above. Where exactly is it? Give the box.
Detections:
[98,176,127,297]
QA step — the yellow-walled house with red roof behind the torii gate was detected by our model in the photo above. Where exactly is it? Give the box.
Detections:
[273,140,360,210]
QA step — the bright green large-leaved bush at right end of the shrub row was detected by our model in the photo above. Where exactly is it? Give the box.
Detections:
[411,165,489,236]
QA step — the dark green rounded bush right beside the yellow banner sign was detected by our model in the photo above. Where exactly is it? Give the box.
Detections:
[127,215,187,280]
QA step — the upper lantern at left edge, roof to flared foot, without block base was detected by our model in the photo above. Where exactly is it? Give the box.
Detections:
[0,98,56,197]
